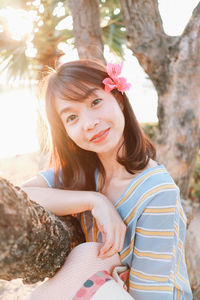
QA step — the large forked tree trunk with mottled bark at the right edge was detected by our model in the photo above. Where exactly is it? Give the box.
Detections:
[120,0,200,198]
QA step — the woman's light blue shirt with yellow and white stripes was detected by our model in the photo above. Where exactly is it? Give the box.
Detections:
[40,165,192,300]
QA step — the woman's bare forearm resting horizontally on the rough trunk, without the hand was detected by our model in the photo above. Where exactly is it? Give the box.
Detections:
[21,186,99,216]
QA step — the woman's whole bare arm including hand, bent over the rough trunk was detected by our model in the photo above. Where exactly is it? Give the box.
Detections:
[21,176,126,257]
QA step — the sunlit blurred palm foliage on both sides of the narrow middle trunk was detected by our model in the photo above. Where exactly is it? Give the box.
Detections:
[0,0,126,82]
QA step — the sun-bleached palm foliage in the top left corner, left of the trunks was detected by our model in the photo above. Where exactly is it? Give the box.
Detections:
[0,0,73,82]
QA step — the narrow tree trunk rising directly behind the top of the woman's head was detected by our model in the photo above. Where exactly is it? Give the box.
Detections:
[69,0,105,64]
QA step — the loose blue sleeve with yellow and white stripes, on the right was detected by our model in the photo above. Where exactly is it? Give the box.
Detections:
[129,189,177,300]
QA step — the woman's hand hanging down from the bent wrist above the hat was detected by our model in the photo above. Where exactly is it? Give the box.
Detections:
[91,194,126,258]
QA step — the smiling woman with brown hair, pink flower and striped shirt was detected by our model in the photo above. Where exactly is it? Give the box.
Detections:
[24,60,192,300]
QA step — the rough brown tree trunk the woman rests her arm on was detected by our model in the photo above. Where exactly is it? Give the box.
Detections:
[0,178,85,284]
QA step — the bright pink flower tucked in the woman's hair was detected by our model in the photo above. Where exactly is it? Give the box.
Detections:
[103,62,131,94]
